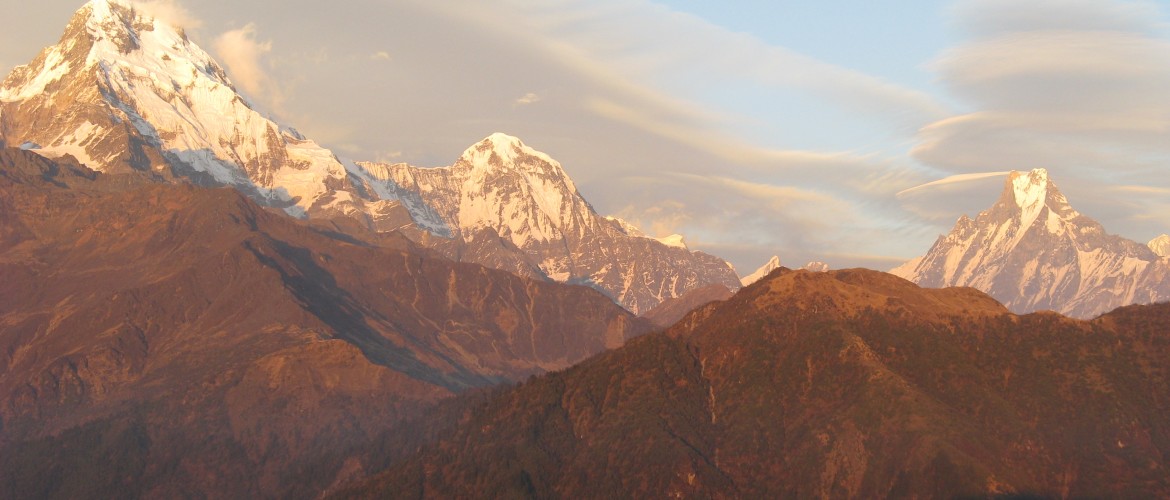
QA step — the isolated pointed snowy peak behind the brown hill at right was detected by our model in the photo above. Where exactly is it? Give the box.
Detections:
[892,169,1170,317]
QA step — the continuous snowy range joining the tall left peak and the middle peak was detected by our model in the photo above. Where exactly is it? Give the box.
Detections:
[0,0,739,313]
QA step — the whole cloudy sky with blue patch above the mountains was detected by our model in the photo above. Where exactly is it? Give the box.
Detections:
[0,0,1170,274]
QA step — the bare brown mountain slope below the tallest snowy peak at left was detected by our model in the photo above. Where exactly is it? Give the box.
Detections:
[0,149,644,498]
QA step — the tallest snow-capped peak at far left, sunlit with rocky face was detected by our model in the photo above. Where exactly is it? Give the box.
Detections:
[0,0,365,215]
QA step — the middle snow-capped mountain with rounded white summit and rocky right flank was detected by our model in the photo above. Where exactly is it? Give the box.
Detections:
[359,133,738,313]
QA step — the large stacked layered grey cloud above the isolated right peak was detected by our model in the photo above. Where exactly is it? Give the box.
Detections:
[900,0,1170,242]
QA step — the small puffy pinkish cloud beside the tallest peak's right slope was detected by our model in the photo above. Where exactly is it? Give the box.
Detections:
[212,22,284,114]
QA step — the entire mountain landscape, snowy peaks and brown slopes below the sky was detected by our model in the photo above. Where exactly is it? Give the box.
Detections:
[0,0,1170,499]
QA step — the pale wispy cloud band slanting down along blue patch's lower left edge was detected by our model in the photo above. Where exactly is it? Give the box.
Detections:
[409,0,948,147]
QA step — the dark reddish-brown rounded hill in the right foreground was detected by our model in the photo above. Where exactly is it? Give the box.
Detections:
[347,269,1170,498]
